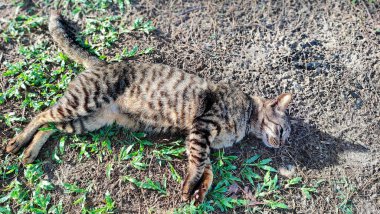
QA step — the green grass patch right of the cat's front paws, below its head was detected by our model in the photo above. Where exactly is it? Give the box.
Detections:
[175,150,317,213]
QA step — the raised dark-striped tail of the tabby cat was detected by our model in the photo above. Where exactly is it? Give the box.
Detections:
[49,10,105,68]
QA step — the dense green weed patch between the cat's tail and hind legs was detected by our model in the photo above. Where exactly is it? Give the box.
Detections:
[1,41,79,113]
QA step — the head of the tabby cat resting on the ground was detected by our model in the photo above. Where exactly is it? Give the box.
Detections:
[253,93,292,148]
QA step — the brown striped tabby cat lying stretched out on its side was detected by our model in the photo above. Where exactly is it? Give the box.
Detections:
[6,11,292,204]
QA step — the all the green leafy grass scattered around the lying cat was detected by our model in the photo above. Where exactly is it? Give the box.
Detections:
[0,0,322,213]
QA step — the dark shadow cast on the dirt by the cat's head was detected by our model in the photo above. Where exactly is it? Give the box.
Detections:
[227,118,370,170]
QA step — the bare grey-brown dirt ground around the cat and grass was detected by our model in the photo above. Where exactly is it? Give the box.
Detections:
[0,1,380,213]
